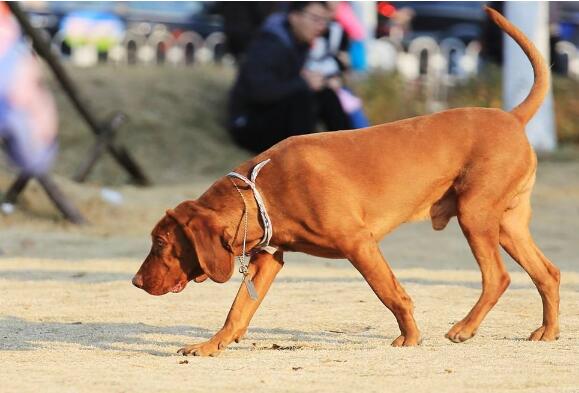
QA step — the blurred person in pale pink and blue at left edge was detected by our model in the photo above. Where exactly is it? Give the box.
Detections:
[0,2,58,175]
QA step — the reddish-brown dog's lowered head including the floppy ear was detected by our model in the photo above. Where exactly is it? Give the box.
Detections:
[133,201,234,295]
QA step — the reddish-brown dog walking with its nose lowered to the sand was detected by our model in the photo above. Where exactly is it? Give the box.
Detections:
[133,8,559,356]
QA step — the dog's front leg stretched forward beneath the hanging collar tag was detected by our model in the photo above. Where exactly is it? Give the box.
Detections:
[177,252,283,356]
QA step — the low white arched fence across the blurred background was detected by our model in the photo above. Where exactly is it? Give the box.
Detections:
[45,24,579,86]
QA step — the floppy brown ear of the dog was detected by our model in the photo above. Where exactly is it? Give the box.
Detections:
[167,205,234,283]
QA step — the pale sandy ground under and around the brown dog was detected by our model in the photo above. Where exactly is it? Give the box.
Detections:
[0,162,579,392]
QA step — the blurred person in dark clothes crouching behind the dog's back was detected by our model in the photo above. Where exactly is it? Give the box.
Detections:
[229,1,351,153]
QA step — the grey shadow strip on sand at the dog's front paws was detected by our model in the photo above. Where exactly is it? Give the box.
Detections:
[0,316,394,356]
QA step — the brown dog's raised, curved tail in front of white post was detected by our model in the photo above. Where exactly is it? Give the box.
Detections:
[485,7,549,124]
